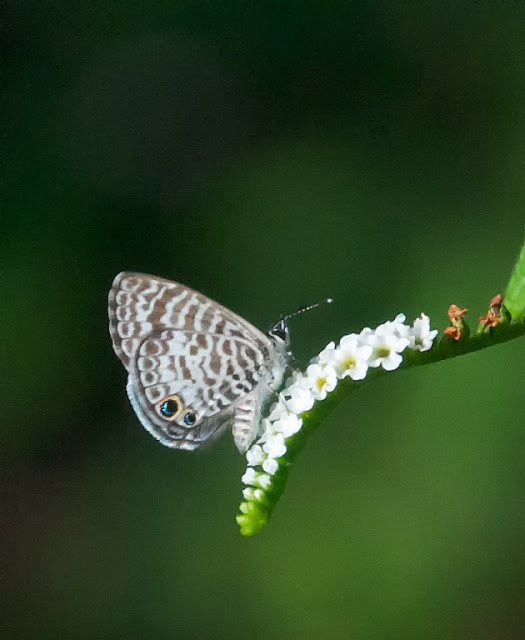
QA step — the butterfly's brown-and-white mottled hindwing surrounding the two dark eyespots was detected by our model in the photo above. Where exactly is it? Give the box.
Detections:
[130,329,265,448]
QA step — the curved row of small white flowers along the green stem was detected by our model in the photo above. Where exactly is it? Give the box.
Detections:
[241,313,438,500]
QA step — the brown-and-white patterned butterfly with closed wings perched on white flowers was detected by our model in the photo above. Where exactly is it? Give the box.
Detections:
[108,272,290,453]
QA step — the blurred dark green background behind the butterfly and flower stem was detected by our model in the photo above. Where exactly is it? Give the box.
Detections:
[4,0,525,640]
